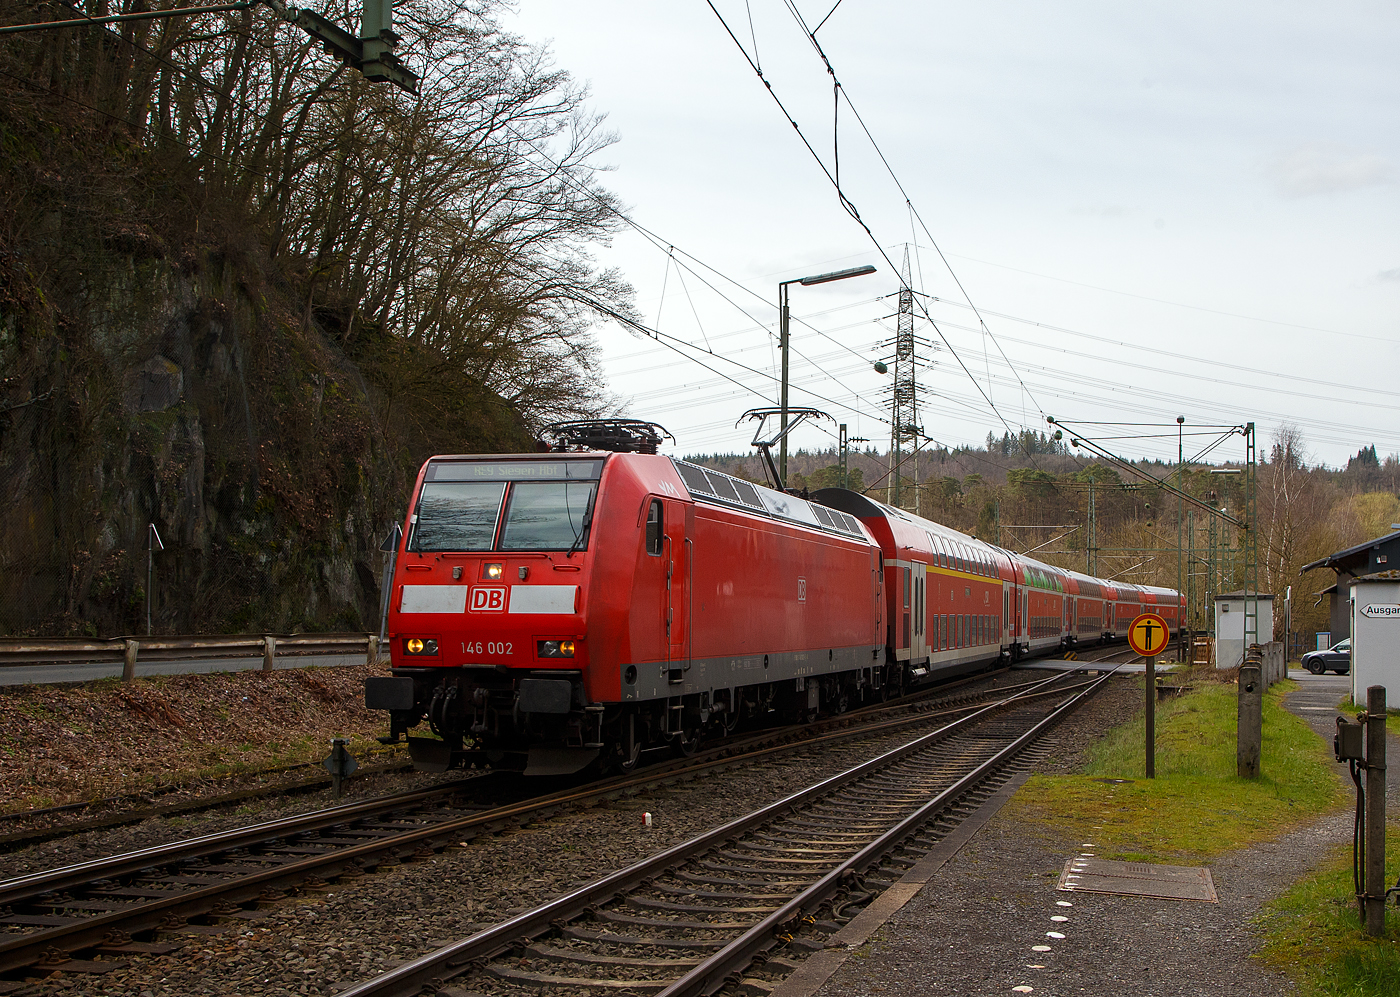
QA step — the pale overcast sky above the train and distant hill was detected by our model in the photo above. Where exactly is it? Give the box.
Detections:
[505,0,1400,465]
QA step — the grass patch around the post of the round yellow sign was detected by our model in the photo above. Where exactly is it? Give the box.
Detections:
[1009,681,1350,863]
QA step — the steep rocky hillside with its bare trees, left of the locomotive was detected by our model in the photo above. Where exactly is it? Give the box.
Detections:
[0,0,630,636]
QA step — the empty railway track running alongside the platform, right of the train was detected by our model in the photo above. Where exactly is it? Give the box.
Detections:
[330,660,1109,997]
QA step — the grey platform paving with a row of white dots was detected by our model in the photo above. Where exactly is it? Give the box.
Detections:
[795,674,1372,997]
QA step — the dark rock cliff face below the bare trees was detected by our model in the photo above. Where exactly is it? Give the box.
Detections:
[0,113,529,636]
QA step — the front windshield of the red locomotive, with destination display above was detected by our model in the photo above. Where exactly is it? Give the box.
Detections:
[409,461,602,553]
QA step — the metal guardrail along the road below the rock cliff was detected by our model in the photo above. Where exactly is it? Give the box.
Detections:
[0,633,379,682]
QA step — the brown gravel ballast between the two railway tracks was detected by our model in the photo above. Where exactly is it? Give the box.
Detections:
[16,669,1064,997]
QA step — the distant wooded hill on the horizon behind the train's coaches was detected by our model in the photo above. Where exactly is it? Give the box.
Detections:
[686,436,1400,633]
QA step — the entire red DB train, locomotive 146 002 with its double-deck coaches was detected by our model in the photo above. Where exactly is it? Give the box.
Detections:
[365,451,1177,773]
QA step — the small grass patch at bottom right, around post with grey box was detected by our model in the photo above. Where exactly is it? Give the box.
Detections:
[1259,842,1400,997]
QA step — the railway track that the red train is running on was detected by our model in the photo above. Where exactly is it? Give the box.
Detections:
[0,660,1097,993]
